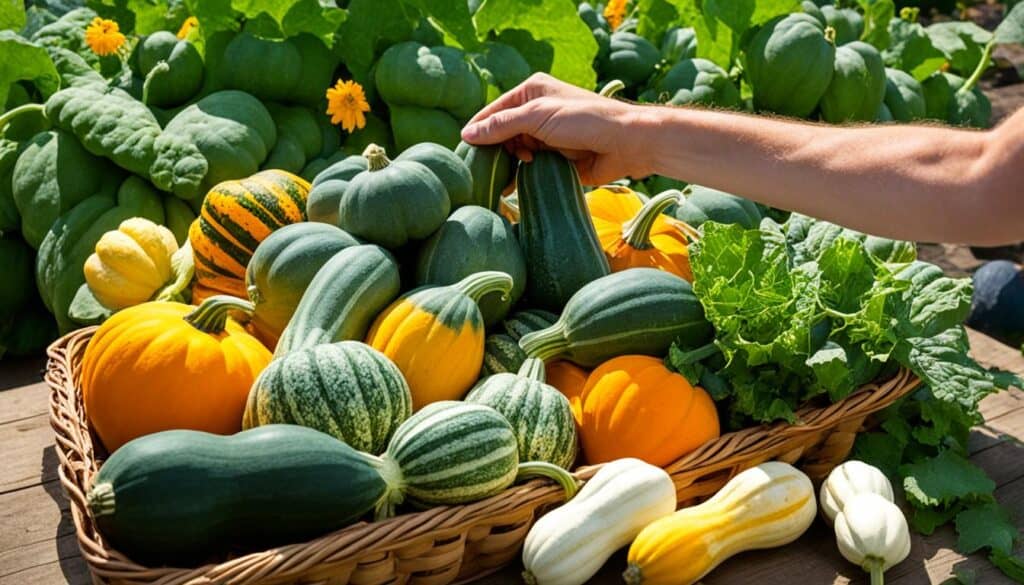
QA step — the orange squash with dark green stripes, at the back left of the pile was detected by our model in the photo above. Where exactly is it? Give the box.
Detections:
[188,170,309,298]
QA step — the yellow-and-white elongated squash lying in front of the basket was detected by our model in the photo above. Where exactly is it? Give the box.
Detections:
[623,461,817,585]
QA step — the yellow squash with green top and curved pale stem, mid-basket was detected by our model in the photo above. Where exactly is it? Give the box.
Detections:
[367,271,512,410]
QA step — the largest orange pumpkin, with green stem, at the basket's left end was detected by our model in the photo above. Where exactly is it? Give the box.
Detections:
[82,296,270,453]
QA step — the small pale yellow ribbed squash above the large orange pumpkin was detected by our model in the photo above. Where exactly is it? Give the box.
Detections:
[82,217,193,310]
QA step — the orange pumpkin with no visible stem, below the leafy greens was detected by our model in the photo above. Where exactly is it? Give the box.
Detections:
[580,356,720,467]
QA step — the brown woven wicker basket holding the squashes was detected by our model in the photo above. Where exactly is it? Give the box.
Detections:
[46,329,918,585]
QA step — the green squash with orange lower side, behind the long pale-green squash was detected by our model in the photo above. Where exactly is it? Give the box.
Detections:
[246,221,359,348]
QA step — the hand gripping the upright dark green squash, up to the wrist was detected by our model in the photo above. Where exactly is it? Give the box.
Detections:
[462,73,650,184]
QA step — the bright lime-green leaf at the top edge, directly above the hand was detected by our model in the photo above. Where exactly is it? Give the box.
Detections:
[473,0,597,89]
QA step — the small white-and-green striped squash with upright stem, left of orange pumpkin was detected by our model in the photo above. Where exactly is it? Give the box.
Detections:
[466,358,578,467]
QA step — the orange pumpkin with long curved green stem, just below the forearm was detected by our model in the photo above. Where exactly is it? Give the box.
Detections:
[587,185,696,282]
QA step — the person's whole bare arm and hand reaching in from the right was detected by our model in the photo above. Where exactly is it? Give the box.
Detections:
[463,76,1024,245]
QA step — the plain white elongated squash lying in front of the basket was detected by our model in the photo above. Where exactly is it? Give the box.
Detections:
[522,459,676,585]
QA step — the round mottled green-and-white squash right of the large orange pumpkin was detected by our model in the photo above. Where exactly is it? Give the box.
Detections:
[242,341,413,455]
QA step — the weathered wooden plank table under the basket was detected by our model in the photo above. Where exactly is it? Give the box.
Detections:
[0,333,1024,585]
